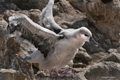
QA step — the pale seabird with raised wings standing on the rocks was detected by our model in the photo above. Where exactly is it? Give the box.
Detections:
[8,0,97,76]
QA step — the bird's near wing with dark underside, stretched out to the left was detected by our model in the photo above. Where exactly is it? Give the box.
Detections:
[8,14,59,57]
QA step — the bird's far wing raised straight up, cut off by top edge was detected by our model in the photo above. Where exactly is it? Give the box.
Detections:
[40,0,62,33]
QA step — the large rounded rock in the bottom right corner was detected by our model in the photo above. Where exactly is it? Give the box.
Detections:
[85,62,120,80]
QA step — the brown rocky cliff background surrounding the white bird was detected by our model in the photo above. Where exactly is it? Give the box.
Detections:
[0,0,120,80]
